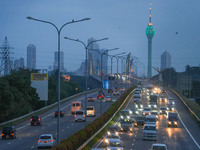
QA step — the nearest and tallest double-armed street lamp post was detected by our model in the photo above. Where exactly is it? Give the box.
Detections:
[26,16,91,144]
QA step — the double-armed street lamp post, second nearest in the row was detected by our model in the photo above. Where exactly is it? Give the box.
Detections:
[64,37,108,122]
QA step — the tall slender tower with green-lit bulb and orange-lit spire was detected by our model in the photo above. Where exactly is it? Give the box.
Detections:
[145,2,155,78]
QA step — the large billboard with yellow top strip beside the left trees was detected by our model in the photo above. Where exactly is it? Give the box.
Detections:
[31,73,48,101]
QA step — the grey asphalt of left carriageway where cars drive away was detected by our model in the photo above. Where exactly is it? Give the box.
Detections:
[0,91,117,150]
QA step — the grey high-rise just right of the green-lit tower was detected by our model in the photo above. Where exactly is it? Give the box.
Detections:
[160,51,171,70]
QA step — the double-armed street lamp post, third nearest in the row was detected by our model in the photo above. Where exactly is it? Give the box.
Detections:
[89,48,119,116]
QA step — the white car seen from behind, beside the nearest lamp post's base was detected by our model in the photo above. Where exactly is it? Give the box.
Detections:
[38,134,55,149]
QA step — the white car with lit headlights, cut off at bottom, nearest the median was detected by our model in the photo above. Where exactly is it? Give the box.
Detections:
[106,139,124,150]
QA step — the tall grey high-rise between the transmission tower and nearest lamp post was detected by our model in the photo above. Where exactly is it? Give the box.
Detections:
[27,44,36,70]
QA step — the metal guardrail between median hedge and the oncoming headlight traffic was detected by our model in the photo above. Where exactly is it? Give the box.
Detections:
[78,88,133,150]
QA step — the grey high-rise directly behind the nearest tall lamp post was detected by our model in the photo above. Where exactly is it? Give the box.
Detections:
[53,51,64,71]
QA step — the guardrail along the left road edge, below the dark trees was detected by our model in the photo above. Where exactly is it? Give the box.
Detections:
[0,89,99,126]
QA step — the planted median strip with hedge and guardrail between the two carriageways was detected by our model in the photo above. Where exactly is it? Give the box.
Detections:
[51,87,135,150]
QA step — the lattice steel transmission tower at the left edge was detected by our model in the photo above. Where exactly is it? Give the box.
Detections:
[0,37,13,76]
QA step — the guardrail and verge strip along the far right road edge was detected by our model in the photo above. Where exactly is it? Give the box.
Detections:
[171,89,200,122]
